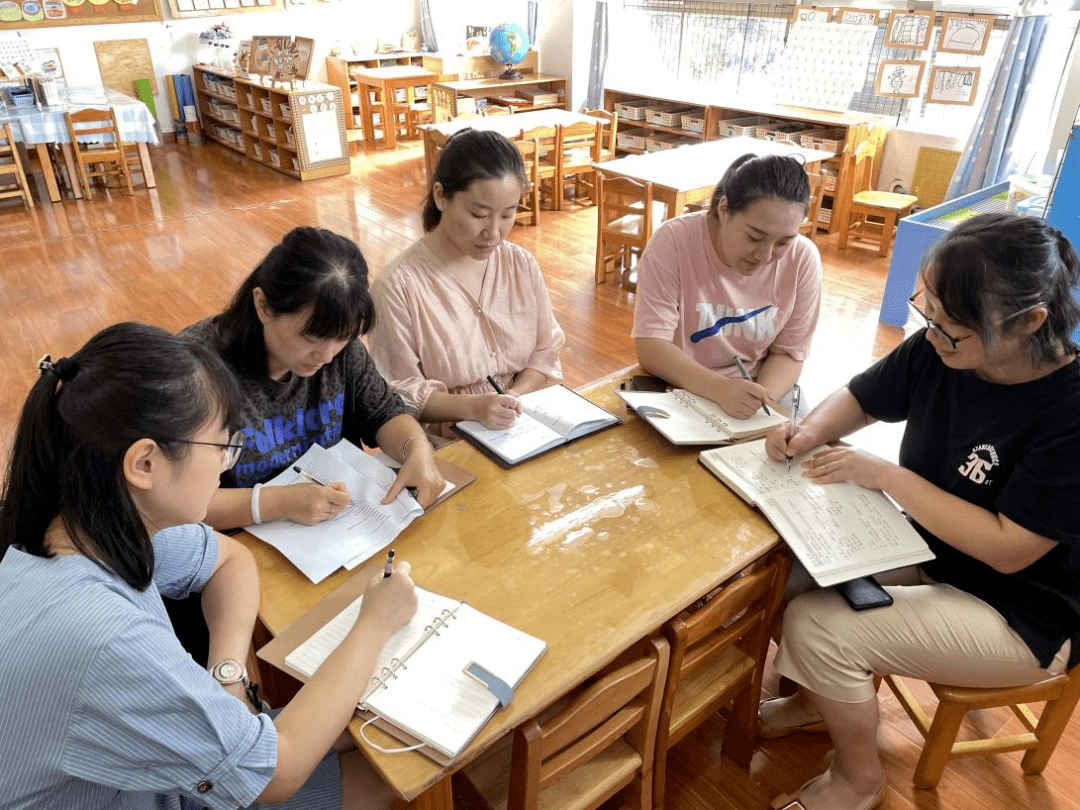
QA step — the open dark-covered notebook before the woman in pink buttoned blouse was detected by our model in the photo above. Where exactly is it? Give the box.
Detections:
[454,386,620,467]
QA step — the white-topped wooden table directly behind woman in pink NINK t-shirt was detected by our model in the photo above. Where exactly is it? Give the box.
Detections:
[593,137,835,219]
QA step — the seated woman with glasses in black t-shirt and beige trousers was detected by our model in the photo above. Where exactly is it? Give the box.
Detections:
[760,214,1080,810]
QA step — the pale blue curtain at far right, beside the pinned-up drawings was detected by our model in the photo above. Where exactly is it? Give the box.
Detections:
[945,16,1048,200]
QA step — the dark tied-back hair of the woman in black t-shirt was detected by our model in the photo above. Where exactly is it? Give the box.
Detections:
[926,213,1080,363]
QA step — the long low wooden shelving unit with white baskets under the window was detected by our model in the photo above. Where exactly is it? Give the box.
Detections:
[604,90,889,232]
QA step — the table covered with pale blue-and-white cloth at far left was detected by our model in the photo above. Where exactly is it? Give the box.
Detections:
[0,87,160,202]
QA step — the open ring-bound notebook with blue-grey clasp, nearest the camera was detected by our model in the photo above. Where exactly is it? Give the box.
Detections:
[274,588,548,762]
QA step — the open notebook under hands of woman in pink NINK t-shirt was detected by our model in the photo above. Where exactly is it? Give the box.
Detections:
[616,388,787,444]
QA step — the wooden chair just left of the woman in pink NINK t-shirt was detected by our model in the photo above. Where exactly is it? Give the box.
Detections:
[595,172,659,286]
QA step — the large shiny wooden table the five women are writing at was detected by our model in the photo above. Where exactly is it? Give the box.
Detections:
[238,369,779,810]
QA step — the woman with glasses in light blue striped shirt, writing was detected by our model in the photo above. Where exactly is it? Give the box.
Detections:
[0,323,416,810]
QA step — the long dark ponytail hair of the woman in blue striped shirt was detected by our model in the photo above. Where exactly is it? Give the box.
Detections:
[0,323,239,591]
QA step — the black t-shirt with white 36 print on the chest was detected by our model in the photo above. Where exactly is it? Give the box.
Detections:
[849,330,1080,666]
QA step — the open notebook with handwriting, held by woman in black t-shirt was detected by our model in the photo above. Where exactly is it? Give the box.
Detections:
[699,440,934,588]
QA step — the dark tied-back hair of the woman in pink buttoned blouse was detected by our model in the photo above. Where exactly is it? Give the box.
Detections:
[421,127,528,233]
